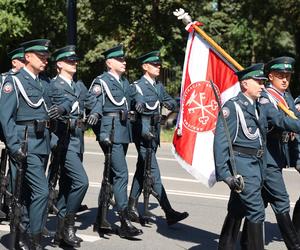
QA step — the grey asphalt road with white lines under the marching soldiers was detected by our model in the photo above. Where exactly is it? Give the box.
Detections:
[0,138,300,250]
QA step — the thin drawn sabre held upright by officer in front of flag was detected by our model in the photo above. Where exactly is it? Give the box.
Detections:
[209,80,245,193]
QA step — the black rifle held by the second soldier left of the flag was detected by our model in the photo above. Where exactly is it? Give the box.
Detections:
[94,117,115,233]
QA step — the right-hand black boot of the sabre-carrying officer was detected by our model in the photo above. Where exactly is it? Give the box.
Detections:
[241,221,264,250]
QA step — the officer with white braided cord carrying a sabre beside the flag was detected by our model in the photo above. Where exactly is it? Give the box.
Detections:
[214,64,267,250]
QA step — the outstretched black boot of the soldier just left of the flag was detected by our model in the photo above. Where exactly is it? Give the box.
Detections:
[159,187,189,225]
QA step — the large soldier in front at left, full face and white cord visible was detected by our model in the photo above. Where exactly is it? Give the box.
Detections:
[0,39,57,249]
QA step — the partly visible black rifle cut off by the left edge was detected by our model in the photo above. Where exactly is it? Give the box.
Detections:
[0,148,11,219]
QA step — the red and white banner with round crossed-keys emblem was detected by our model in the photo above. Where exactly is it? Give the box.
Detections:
[172,25,240,187]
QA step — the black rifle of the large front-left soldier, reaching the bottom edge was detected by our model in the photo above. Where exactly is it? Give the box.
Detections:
[10,126,28,250]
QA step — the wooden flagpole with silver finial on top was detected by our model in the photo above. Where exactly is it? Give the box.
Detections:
[173,8,298,120]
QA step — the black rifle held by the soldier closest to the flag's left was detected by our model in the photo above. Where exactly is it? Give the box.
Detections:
[143,116,159,219]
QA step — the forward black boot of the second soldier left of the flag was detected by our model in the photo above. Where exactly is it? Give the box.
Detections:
[119,208,143,238]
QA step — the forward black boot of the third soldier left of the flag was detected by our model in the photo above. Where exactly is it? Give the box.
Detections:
[63,213,80,247]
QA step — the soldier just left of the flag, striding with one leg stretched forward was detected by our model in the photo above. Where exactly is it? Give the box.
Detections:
[128,51,188,225]
